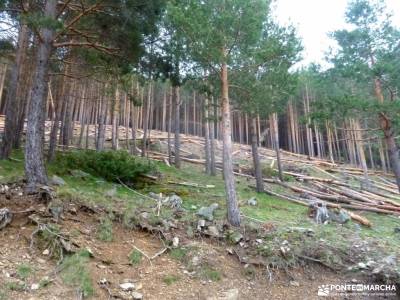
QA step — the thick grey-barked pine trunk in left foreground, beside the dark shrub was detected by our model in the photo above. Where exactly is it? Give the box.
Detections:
[25,0,57,192]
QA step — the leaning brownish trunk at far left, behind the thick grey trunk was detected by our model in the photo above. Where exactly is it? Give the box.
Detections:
[0,24,29,159]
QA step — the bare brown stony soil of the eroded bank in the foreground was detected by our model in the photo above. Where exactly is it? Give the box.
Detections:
[0,195,394,300]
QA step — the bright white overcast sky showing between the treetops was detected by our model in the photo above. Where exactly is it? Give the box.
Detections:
[274,0,400,66]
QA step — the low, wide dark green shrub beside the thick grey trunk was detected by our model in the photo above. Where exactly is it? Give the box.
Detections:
[53,150,156,184]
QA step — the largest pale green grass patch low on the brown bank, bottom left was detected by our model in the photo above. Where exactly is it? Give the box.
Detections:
[60,250,94,297]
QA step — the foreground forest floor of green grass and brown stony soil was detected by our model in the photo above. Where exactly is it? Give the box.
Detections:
[0,149,400,300]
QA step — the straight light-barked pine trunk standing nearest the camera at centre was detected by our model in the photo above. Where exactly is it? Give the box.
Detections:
[221,59,240,226]
